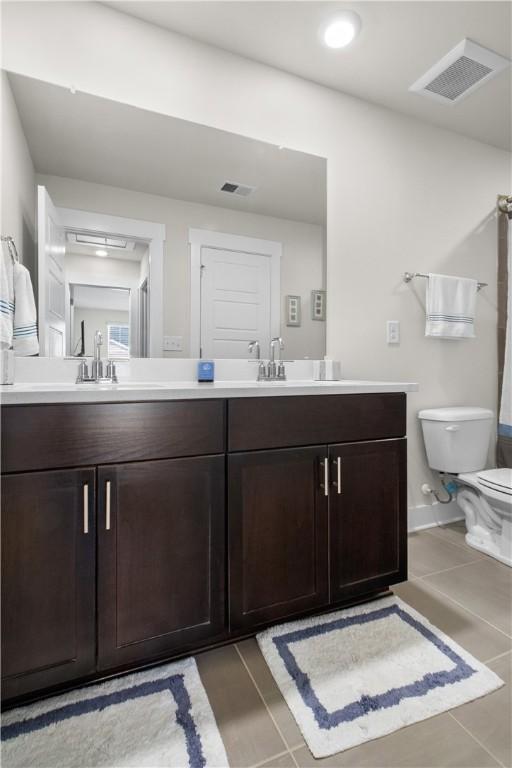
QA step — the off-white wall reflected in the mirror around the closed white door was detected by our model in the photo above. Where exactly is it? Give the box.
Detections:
[37,174,326,359]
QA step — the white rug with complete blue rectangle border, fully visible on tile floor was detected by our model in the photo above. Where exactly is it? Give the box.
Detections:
[257,597,503,757]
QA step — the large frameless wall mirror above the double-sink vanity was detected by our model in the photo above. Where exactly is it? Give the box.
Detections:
[9,74,327,359]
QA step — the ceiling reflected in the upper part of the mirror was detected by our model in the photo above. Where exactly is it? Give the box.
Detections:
[9,74,326,224]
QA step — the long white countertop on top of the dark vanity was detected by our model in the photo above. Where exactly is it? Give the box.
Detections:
[0,379,418,405]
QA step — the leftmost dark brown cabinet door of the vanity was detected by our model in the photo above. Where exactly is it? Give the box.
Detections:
[2,469,96,698]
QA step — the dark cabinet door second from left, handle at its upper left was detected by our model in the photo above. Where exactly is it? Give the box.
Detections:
[98,456,225,669]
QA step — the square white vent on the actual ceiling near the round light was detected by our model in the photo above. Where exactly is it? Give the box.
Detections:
[409,38,510,104]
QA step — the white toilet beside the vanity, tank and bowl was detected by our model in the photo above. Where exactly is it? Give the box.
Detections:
[418,408,512,566]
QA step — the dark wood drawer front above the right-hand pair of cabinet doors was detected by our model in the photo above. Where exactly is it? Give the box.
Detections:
[228,392,406,451]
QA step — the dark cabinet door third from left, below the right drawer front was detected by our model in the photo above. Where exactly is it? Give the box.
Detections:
[228,446,328,630]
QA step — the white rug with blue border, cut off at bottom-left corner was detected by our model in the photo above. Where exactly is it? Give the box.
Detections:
[2,658,228,768]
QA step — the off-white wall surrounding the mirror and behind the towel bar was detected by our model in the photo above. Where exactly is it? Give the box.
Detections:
[3,2,511,505]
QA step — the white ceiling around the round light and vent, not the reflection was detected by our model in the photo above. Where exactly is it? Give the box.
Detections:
[107,0,512,149]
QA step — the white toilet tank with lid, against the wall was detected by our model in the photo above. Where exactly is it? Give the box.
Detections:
[418,408,494,474]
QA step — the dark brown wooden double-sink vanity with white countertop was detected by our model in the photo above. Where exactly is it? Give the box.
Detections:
[2,382,407,703]
